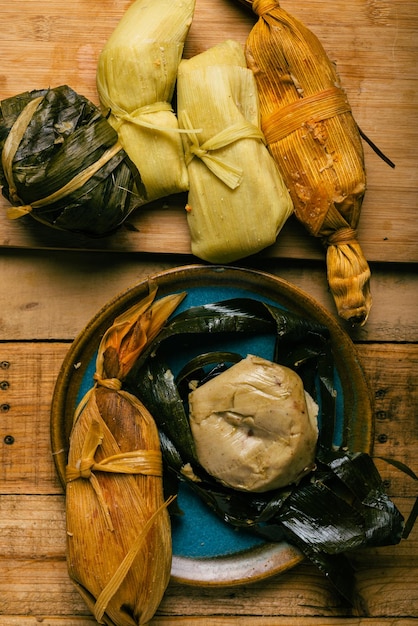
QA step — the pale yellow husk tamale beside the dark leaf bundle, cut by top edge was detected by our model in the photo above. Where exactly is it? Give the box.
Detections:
[96,0,195,201]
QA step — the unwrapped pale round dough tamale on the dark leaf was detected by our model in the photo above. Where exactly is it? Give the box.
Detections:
[189,355,318,492]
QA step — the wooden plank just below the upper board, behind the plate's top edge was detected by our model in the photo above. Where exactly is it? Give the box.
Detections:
[0,250,418,342]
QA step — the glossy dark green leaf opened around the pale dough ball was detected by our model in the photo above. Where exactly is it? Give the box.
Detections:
[128,298,404,605]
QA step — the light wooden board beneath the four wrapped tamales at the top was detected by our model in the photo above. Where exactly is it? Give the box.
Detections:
[0,0,418,262]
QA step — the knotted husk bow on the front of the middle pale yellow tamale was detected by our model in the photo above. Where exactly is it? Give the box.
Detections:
[180,111,265,189]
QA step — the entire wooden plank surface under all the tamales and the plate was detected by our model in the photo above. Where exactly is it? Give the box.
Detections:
[0,0,418,626]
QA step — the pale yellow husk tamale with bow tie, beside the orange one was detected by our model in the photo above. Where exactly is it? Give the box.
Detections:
[177,41,293,263]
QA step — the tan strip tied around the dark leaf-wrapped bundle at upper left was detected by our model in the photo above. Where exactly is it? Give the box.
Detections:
[2,96,122,219]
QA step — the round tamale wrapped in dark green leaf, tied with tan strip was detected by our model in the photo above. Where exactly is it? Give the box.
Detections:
[0,85,145,236]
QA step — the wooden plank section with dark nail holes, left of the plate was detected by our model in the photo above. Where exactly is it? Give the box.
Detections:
[0,344,68,492]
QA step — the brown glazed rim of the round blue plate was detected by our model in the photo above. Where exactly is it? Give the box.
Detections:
[50,264,374,586]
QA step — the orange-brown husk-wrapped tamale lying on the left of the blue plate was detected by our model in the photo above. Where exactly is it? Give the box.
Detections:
[66,290,184,626]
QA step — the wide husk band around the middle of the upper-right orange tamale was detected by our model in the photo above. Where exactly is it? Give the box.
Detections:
[262,87,351,144]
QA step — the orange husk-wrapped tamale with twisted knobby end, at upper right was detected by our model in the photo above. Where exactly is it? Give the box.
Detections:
[245,0,371,324]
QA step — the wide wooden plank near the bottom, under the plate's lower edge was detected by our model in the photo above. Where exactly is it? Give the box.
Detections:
[0,510,418,624]
